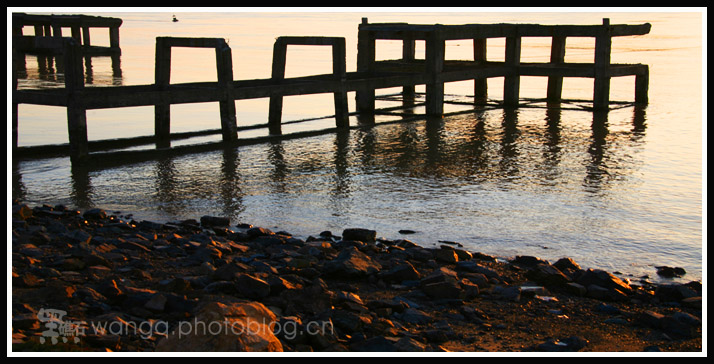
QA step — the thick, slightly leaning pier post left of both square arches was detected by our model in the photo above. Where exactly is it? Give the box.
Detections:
[64,38,89,162]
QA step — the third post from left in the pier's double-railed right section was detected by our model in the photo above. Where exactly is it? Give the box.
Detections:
[426,29,445,117]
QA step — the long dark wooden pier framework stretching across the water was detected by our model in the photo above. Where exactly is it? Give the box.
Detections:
[13,19,650,160]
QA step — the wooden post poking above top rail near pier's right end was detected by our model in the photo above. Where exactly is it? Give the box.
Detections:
[593,18,612,110]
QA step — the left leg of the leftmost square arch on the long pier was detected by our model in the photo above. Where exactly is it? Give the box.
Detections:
[154,37,171,148]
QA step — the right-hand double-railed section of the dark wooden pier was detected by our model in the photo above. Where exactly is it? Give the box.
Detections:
[357,18,651,115]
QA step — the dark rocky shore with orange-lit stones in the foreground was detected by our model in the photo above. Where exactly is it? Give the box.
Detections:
[11,201,702,353]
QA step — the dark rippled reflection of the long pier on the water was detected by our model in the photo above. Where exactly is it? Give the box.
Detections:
[13,106,646,217]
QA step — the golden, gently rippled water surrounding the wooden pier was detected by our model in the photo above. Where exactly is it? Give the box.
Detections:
[8,11,706,280]
